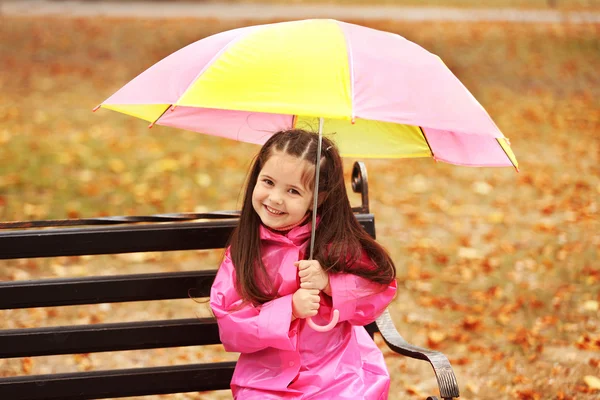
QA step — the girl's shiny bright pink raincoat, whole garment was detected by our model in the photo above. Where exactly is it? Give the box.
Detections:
[210,223,396,400]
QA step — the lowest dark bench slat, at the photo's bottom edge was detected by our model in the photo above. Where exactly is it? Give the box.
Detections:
[0,362,235,400]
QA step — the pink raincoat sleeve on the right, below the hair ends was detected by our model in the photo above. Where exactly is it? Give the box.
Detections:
[329,254,396,326]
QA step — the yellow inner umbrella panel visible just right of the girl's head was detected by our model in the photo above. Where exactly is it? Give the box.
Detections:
[296,117,432,158]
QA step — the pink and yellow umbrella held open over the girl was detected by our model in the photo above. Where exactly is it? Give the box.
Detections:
[94,19,518,332]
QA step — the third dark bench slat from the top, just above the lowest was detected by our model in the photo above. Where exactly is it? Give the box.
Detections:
[0,318,221,359]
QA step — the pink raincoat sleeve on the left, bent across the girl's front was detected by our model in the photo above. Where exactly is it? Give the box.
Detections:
[210,249,298,353]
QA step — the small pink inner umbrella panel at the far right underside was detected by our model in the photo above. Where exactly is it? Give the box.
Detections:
[423,128,512,167]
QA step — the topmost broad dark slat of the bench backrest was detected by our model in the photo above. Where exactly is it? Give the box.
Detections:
[0,214,375,259]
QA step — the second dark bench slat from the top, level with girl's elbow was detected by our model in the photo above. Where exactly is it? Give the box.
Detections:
[0,270,216,310]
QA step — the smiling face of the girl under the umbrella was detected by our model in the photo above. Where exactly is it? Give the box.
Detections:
[252,152,313,230]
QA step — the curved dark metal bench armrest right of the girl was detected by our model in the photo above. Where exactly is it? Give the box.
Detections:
[376,310,459,399]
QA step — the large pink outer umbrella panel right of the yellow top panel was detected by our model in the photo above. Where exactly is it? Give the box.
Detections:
[340,22,502,137]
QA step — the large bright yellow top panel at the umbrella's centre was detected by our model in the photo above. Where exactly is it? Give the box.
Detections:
[177,20,352,118]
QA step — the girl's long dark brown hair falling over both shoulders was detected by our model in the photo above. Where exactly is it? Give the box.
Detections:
[229,129,396,304]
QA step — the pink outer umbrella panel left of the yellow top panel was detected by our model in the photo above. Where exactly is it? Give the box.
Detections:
[105,27,256,104]
